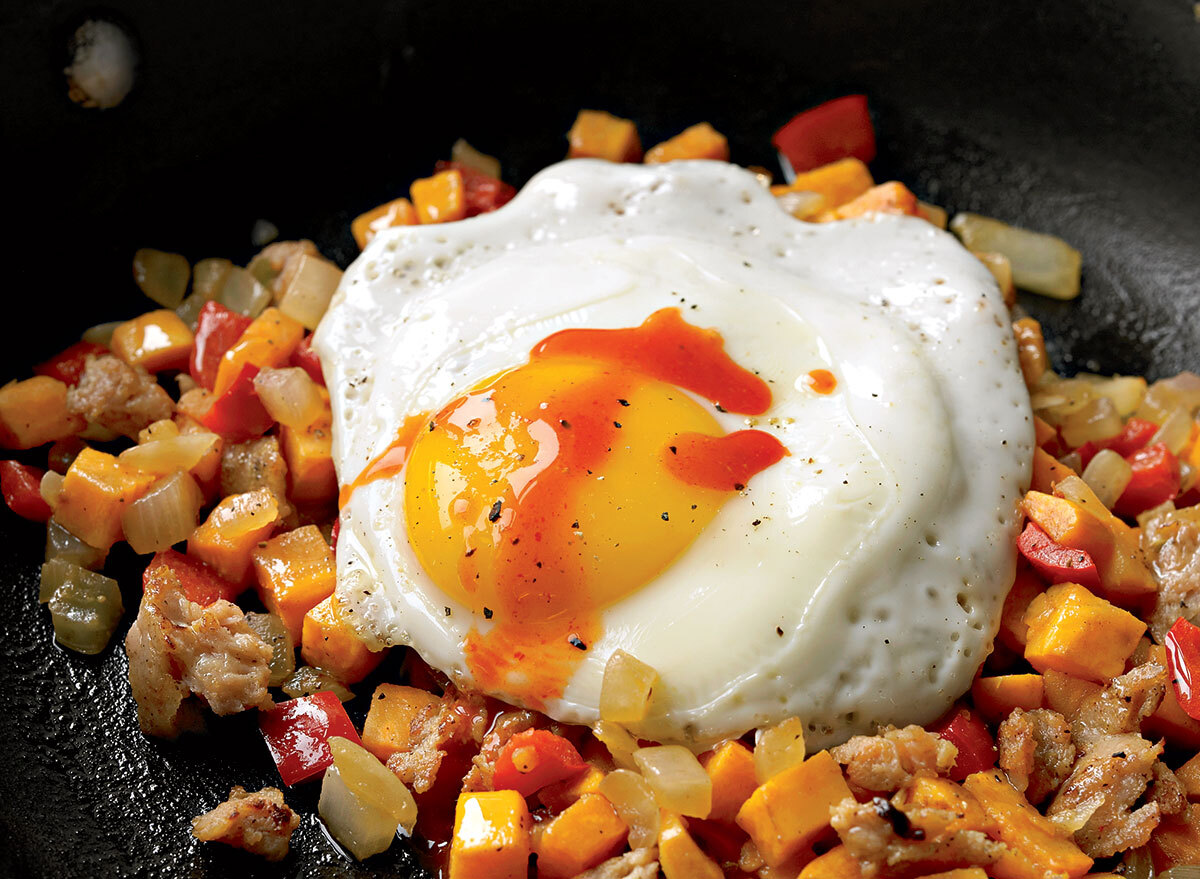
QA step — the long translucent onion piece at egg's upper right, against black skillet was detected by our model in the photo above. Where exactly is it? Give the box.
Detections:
[950,214,1082,299]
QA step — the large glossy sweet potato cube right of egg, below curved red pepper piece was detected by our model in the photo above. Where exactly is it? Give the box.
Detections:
[1025,582,1146,682]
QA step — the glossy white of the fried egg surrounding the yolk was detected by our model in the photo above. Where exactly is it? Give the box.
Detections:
[314,161,1033,747]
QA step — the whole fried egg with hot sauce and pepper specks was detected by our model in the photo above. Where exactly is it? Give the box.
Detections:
[314,161,1033,748]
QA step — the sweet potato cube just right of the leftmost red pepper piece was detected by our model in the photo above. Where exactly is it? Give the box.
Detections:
[54,448,158,550]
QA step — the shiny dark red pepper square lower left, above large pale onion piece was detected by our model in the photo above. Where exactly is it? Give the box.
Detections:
[258,690,362,787]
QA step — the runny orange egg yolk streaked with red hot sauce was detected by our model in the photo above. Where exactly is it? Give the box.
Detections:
[393,309,787,707]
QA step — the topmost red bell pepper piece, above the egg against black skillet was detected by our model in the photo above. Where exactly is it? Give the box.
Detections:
[770,95,875,173]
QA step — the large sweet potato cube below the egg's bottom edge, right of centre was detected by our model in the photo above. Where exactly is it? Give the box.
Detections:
[737,751,851,867]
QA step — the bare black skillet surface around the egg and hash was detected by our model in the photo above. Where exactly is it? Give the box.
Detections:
[0,0,1200,877]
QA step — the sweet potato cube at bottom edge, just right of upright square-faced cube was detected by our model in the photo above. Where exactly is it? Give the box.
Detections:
[533,794,629,879]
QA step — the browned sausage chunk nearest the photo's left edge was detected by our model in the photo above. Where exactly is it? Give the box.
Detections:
[67,354,175,440]
